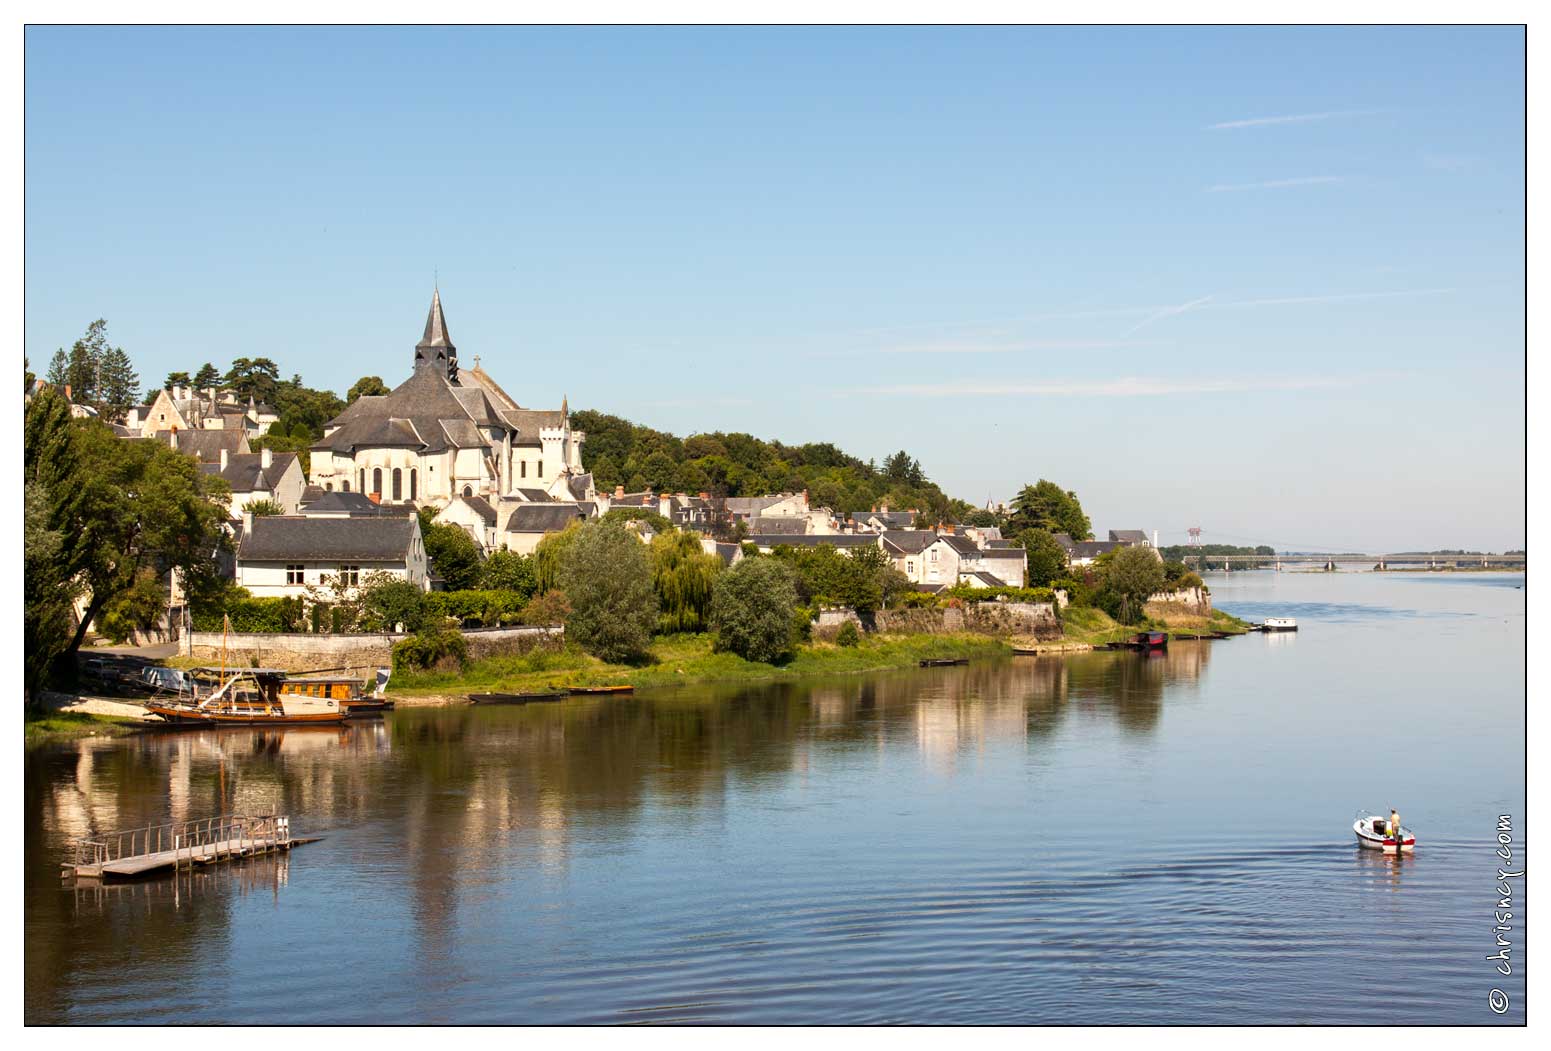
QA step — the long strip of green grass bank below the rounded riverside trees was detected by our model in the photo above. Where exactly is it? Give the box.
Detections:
[389,634,1011,696]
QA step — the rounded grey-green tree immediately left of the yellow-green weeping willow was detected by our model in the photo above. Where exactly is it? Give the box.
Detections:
[560,522,658,660]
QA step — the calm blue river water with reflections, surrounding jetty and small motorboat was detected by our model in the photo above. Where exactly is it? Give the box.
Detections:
[26,574,1525,1023]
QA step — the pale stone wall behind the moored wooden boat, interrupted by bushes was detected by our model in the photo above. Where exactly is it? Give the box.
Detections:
[178,625,565,671]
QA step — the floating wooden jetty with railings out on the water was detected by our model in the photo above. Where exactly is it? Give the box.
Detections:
[60,814,318,879]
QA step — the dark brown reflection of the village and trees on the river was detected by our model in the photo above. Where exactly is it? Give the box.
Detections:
[26,643,1211,1015]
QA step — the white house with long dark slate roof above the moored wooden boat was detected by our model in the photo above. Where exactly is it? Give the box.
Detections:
[237,515,430,598]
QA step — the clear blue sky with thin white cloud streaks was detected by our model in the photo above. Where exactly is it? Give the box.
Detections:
[26,28,1525,549]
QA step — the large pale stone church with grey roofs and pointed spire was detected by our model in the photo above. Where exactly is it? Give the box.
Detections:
[310,290,596,507]
